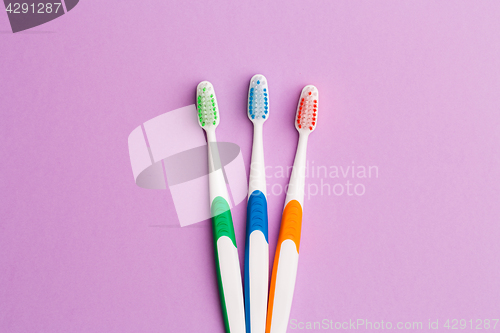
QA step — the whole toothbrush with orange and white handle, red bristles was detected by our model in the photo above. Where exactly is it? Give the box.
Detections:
[266,85,318,333]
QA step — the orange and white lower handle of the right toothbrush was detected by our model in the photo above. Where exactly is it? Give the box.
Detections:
[266,200,302,333]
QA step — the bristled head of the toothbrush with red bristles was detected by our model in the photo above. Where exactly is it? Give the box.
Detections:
[295,85,318,133]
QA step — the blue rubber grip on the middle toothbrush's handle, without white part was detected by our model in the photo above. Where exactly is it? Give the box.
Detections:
[245,190,269,333]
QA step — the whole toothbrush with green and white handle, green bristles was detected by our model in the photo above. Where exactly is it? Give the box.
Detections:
[196,81,245,333]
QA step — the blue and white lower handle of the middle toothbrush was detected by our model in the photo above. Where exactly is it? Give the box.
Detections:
[245,190,269,333]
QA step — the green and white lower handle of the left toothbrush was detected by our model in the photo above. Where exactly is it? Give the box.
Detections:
[211,197,245,333]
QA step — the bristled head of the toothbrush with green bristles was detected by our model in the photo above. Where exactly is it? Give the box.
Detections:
[196,81,220,130]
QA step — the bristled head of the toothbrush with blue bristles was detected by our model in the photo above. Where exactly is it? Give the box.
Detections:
[247,74,269,123]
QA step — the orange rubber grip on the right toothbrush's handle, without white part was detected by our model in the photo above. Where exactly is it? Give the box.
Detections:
[266,200,302,333]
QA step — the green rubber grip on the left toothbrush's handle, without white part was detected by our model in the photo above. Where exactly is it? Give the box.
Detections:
[211,197,236,333]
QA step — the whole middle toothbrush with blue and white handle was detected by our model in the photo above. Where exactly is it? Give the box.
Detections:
[245,74,269,333]
